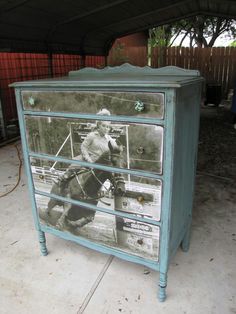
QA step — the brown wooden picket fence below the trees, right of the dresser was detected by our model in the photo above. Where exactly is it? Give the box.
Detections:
[152,47,236,96]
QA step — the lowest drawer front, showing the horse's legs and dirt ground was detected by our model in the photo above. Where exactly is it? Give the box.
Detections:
[36,194,160,261]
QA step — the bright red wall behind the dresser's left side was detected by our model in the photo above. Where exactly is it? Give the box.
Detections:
[0,52,105,124]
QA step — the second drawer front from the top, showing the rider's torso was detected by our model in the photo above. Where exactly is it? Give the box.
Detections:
[25,116,164,174]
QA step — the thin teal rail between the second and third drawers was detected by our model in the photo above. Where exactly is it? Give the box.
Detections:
[29,152,163,180]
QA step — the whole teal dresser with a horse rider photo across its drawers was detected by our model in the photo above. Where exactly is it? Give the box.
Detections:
[11,64,202,301]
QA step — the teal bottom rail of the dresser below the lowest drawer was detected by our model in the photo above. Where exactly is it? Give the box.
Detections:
[41,225,159,271]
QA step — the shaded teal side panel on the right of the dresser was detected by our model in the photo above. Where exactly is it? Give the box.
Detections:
[170,85,201,255]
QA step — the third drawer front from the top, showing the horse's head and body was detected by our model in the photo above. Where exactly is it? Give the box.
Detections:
[31,158,162,222]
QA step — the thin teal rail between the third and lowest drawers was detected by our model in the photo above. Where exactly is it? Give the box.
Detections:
[35,190,161,227]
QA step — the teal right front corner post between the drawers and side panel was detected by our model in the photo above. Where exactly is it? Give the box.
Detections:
[159,89,175,273]
